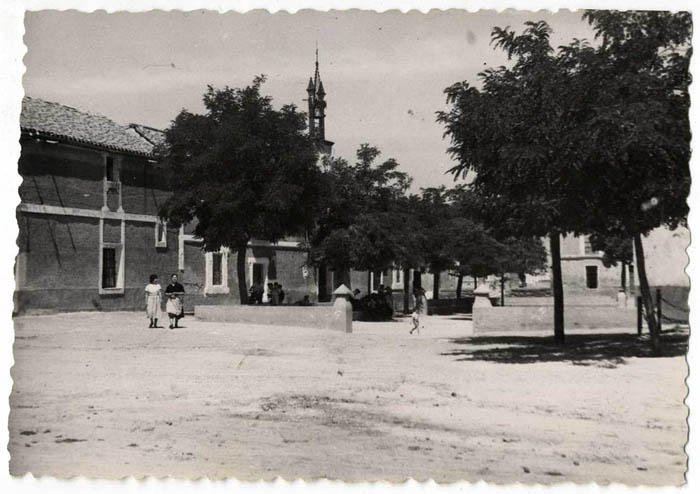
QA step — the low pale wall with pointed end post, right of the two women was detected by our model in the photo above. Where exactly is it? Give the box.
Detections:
[194,300,352,333]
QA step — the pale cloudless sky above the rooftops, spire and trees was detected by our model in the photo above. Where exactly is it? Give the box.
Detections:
[23,10,593,191]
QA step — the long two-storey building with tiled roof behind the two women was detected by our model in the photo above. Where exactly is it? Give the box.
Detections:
[15,97,328,313]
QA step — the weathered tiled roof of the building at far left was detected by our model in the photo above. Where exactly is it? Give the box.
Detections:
[20,96,164,156]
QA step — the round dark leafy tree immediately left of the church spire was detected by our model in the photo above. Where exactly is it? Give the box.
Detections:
[160,76,320,303]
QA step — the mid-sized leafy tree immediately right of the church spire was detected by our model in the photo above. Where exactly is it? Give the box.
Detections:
[310,144,413,286]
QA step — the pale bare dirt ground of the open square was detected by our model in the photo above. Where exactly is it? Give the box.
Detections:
[9,313,687,485]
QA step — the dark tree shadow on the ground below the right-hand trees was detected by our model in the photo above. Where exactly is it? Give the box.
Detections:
[442,328,689,368]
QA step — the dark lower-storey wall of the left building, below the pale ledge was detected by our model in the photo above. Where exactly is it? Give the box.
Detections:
[15,213,185,313]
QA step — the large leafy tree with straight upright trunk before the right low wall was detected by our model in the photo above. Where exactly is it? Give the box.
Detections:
[437,21,586,342]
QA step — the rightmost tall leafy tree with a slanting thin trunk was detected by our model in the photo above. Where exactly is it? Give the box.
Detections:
[562,11,692,350]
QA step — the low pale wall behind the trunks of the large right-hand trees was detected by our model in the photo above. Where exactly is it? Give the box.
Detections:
[472,305,637,334]
